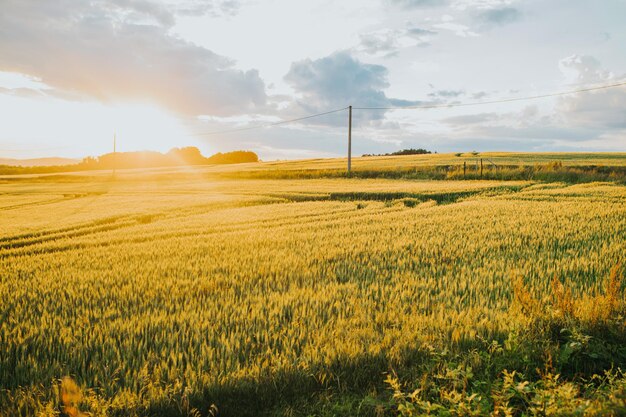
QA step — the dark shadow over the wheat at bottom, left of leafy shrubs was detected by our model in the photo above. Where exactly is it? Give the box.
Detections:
[136,340,506,417]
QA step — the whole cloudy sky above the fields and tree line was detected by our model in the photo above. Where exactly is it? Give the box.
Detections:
[0,0,626,160]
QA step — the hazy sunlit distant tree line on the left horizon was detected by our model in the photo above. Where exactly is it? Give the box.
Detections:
[0,146,259,175]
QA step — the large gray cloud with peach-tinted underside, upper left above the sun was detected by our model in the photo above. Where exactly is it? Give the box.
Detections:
[0,0,267,115]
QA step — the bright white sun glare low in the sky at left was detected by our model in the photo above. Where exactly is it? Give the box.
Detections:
[0,91,200,158]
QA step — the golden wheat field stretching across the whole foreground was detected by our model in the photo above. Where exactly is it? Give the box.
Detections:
[0,161,626,416]
